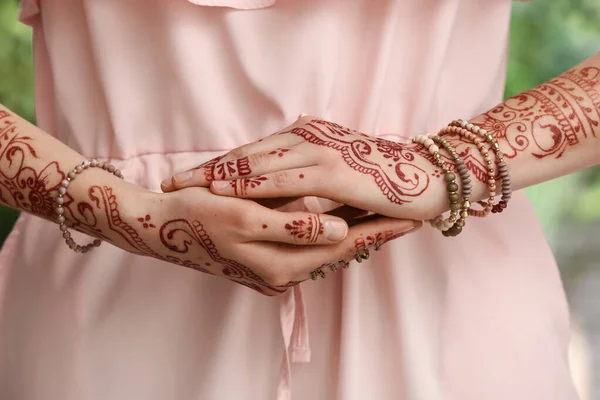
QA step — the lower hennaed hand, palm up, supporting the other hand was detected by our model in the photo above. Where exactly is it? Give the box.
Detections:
[69,186,420,295]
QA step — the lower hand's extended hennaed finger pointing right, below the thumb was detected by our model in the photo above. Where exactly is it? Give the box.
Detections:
[290,217,422,280]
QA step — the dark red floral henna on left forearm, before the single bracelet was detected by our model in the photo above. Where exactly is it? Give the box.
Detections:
[0,110,65,219]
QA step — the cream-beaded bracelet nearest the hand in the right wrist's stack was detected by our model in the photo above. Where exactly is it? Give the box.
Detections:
[412,135,464,236]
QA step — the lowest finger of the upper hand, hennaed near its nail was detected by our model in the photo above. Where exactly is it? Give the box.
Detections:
[210,167,326,200]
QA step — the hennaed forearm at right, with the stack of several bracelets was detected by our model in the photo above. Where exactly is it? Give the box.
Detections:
[440,53,600,208]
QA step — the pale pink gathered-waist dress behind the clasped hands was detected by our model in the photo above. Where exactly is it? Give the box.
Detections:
[0,0,576,400]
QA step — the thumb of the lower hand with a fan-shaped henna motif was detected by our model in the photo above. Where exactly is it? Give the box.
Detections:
[246,211,348,245]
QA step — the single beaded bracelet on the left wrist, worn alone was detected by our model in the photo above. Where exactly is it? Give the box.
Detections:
[54,159,123,253]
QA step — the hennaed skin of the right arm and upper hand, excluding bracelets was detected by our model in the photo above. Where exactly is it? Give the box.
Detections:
[163,53,600,220]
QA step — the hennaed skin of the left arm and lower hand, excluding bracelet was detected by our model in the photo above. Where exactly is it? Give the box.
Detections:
[0,106,420,295]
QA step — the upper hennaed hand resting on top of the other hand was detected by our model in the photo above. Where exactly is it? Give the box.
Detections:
[163,116,445,220]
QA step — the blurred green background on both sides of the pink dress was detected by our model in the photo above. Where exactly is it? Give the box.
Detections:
[0,0,600,399]
